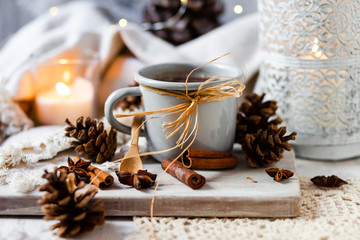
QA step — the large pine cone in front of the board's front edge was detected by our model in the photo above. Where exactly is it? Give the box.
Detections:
[38,168,105,237]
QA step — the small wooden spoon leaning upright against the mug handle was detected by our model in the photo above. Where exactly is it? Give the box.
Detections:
[120,116,143,173]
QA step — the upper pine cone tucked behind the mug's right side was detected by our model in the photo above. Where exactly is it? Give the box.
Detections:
[235,93,282,143]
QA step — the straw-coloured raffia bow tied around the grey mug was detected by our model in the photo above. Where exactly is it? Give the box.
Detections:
[115,67,245,156]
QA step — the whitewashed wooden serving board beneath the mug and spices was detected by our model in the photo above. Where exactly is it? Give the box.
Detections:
[0,149,301,217]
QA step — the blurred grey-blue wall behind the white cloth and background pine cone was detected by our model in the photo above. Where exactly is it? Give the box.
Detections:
[0,0,257,46]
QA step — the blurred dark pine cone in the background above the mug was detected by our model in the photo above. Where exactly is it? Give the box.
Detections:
[143,0,224,45]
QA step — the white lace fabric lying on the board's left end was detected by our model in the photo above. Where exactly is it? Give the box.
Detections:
[0,126,71,192]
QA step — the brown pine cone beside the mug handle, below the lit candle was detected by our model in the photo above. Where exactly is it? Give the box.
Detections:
[65,117,117,163]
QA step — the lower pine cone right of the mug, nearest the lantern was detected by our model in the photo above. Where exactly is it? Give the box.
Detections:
[241,125,296,168]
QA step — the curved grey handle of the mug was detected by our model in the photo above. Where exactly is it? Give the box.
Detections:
[104,87,146,137]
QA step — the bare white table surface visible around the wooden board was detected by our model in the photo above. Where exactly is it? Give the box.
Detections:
[0,158,360,240]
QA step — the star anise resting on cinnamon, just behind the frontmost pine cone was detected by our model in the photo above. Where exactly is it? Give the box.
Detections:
[59,156,91,183]
